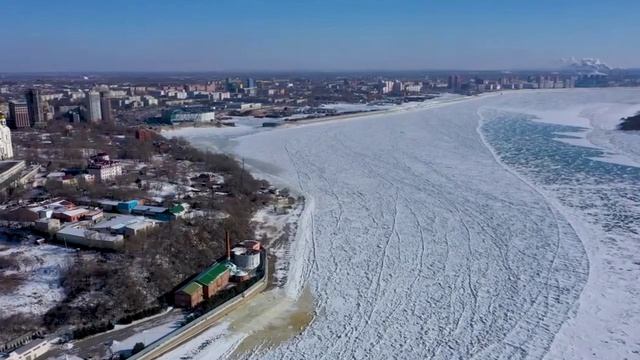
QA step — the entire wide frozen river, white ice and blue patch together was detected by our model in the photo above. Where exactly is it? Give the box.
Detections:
[166,90,640,359]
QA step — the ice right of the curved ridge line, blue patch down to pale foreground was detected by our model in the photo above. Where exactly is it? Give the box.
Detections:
[481,103,640,358]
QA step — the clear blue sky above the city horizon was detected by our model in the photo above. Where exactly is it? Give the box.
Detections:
[0,0,640,72]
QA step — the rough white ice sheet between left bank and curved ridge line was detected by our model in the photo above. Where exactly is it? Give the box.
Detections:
[228,95,587,359]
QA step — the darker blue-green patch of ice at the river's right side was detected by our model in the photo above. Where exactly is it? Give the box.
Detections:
[482,113,640,234]
